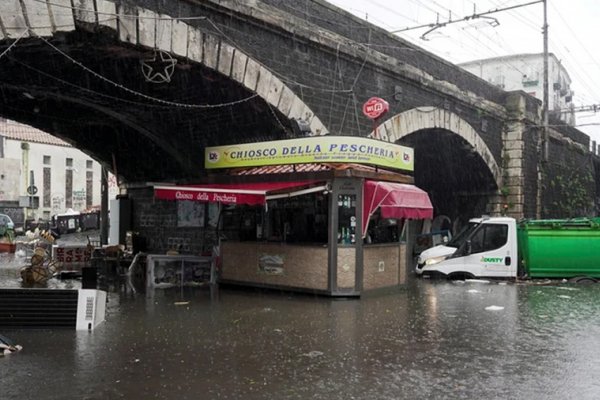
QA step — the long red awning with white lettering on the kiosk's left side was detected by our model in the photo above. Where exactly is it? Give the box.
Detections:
[154,181,325,205]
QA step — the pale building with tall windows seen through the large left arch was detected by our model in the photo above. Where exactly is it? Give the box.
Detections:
[0,119,117,226]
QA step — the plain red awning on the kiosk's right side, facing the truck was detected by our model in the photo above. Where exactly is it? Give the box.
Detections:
[362,181,433,237]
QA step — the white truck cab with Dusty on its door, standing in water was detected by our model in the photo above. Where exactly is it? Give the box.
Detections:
[421,217,519,279]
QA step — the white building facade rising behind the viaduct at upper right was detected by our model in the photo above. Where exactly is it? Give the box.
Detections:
[458,53,575,126]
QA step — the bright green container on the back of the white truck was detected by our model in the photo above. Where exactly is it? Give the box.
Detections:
[517,218,600,278]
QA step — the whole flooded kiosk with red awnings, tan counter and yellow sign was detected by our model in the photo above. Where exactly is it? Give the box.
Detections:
[154,137,433,296]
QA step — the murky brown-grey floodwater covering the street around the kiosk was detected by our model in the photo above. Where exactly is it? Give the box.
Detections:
[0,253,600,400]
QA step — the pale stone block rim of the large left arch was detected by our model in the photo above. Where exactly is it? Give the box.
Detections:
[0,0,329,135]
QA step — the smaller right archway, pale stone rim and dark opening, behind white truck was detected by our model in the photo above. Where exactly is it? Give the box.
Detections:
[377,107,501,230]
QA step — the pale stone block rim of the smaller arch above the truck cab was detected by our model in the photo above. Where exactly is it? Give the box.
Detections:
[369,107,502,188]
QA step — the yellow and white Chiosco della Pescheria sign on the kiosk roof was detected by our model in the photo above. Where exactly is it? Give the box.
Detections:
[204,136,414,171]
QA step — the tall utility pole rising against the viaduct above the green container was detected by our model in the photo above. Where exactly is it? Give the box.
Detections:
[536,0,549,219]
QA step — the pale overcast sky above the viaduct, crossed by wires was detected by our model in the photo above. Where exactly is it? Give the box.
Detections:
[329,0,600,144]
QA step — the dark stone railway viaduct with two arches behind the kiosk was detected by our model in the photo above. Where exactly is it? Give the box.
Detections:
[0,0,600,244]
